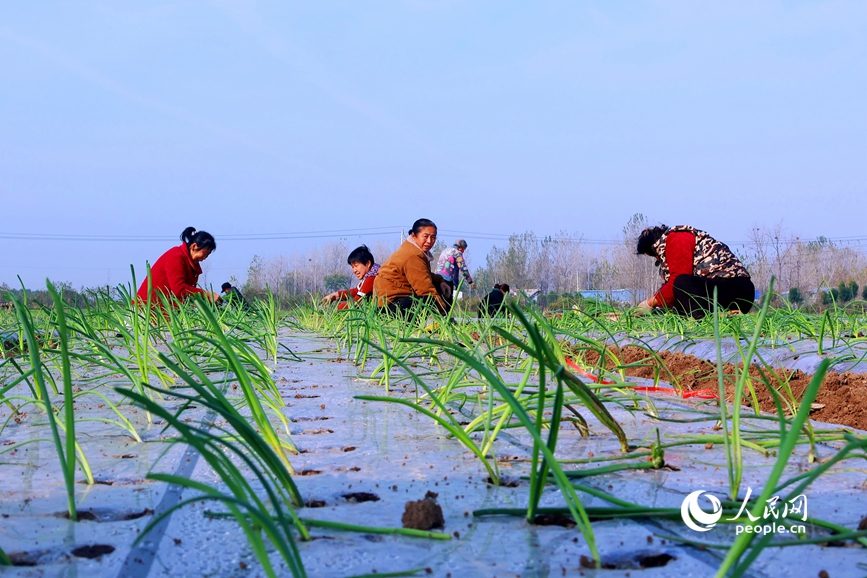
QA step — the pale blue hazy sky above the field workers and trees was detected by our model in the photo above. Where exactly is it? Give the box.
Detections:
[0,0,867,288]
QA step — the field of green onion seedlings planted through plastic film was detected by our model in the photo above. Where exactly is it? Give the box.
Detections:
[0,289,867,577]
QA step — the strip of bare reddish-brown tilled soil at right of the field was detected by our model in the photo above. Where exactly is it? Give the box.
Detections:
[579,345,867,430]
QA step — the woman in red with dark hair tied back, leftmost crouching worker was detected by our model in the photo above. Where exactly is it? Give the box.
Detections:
[137,227,220,303]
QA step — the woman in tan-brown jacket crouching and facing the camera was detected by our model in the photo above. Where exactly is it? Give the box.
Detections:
[373,219,451,314]
